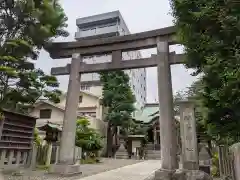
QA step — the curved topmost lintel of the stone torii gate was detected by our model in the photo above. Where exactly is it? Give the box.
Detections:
[44,26,177,59]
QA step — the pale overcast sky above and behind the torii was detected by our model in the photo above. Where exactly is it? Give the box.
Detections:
[36,0,196,102]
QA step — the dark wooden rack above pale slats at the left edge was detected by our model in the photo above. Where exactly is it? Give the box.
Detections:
[0,110,37,169]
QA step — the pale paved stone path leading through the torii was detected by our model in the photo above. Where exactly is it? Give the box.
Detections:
[79,160,160,180]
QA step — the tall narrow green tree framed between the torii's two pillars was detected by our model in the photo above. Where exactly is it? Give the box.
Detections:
[100,71,135,156]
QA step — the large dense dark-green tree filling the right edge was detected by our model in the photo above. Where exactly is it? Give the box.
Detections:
[171,0,240,142]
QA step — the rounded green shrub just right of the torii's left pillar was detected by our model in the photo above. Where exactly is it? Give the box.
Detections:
[76,118,103,152]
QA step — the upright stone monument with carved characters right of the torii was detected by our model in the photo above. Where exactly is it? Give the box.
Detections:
[172,100,212,180]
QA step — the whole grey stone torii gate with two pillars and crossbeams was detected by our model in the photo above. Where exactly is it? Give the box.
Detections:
[45,26,184,178]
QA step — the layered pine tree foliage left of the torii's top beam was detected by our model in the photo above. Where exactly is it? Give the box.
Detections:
[0,0,68,110]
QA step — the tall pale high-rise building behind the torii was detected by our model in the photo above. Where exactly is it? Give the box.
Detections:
[75,11,146,108]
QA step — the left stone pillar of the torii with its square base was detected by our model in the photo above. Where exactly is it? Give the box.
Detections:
[49,54,82,175]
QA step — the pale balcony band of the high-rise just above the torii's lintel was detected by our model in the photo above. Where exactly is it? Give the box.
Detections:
[75,26,120,40]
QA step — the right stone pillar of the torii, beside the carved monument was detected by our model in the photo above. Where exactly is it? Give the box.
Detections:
[155,42,178,180]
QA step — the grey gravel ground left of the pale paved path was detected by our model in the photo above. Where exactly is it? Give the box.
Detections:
[0,159,142,180]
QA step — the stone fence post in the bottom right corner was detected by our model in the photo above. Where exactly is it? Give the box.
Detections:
[230,143,240,180]
